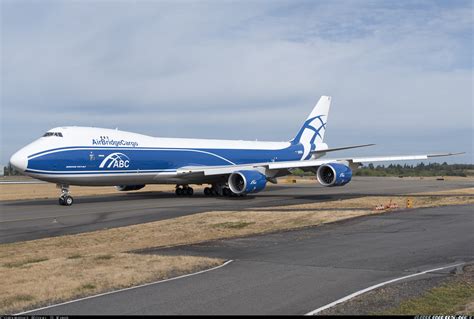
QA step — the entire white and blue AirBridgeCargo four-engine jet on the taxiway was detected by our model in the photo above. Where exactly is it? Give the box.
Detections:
[10,96,459,206]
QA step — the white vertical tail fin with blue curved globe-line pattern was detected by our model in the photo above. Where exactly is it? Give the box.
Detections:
[291,95,331,159]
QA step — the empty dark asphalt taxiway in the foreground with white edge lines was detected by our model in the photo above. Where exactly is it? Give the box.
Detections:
[26,205,474,315]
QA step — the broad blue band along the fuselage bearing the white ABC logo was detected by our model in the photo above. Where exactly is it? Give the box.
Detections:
[28,144,303,174]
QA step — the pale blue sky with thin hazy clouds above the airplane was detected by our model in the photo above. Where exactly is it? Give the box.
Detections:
[0,0,474,164]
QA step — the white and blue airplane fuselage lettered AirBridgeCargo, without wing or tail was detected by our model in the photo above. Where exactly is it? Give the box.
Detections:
[12,127,312,186]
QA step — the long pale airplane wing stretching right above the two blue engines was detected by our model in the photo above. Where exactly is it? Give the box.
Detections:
[177,152,464,177]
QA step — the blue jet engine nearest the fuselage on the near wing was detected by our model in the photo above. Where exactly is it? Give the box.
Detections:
[228,171,267,195]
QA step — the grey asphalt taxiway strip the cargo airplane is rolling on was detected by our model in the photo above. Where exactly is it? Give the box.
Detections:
[0,177,472,243]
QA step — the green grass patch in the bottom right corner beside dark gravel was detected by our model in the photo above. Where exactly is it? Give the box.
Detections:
[376,282,474,315]
